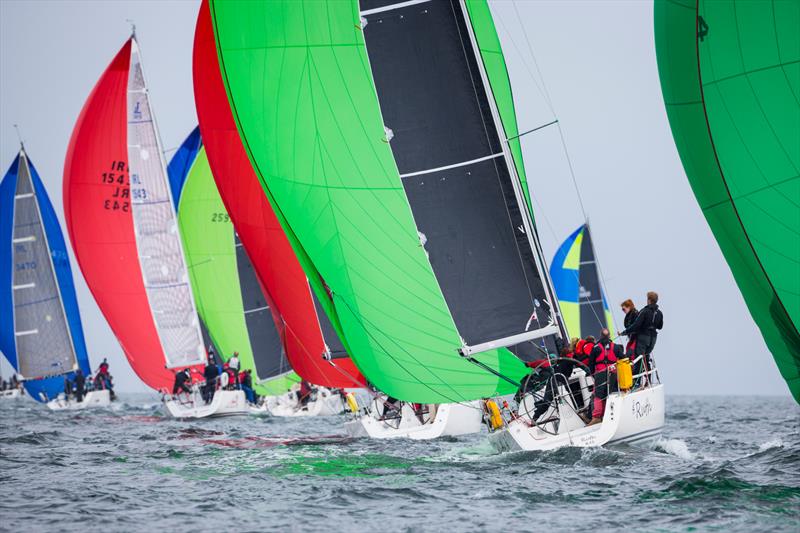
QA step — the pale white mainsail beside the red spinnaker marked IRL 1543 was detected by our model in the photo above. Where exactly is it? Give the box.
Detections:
[128,39,206,368]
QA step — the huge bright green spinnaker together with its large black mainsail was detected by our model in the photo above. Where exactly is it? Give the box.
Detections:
[205,0,565,403]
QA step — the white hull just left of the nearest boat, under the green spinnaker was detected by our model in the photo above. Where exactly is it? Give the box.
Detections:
[344,401,483,440]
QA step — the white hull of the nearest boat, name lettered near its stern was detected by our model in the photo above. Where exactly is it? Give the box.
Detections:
[489,384,665,451]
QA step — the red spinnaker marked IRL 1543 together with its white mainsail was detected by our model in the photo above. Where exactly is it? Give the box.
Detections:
[64,36,206,389]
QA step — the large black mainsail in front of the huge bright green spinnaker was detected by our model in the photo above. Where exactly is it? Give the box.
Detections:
[361,1,552,358]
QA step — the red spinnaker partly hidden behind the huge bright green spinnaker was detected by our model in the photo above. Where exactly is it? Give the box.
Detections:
[193,0,365,387]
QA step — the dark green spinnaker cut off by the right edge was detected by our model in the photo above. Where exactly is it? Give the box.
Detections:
[655,0,800,402]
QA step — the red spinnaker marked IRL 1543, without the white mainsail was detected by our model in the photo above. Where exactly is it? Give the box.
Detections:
[64,39,202,390]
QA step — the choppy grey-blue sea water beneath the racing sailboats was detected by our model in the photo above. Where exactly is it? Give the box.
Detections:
[0,395,800,533]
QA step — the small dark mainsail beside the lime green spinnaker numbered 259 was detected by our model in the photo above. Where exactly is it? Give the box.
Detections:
[234,232,292,381]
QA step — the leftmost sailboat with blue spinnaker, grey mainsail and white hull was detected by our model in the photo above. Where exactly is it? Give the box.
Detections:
[0,146,111,409]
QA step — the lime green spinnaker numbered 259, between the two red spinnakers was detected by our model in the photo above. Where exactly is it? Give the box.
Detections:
[178,148,300,396]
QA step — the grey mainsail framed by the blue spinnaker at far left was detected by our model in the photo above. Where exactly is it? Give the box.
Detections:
[12,152,78,379]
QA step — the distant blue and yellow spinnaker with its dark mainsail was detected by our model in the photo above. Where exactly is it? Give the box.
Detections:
[550,224,614,339]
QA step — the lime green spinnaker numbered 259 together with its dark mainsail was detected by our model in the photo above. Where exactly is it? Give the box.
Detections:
[170,130,299,395]
